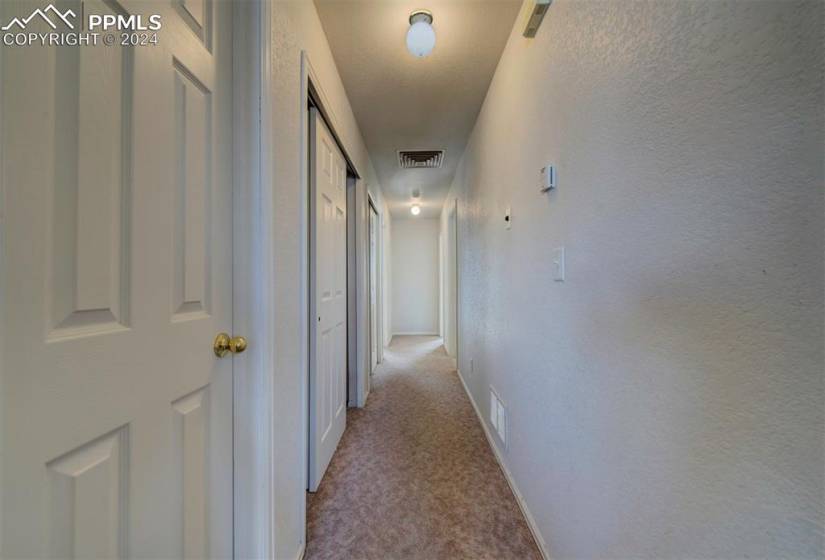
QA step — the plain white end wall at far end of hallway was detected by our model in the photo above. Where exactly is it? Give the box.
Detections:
[392,218,439,334]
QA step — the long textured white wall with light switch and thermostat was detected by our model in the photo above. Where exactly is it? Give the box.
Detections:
[448,0,825,558]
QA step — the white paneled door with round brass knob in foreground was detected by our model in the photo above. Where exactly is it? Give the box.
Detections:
[0,0,232,559]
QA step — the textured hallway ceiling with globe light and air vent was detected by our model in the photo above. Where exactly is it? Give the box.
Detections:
[315,0,521,217]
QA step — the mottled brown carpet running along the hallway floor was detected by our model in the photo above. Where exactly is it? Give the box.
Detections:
[305,336,541,560]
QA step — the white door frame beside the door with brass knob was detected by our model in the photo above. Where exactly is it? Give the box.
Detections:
[233,0,275,558]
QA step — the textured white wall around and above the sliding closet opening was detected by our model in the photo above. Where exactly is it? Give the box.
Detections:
[264,0,384,559]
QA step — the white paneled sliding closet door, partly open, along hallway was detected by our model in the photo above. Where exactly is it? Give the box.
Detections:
[308,109,347,492]
